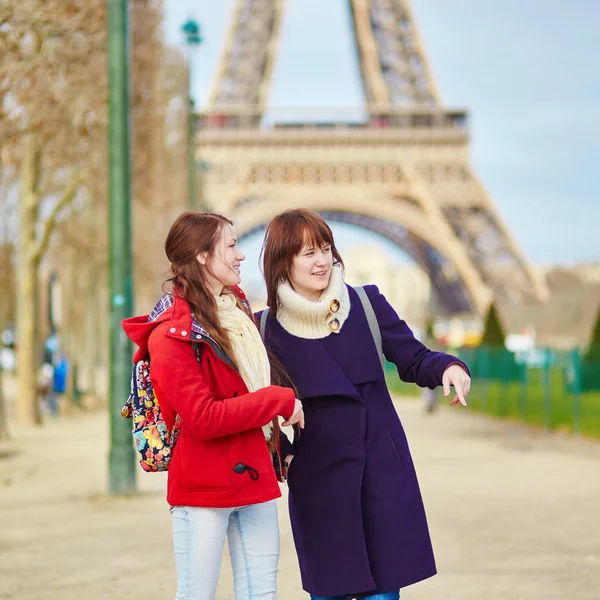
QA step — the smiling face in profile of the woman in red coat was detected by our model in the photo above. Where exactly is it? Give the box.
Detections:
[196,223,246,296]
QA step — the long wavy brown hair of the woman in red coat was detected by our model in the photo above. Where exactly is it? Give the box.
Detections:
[163,212,236,365]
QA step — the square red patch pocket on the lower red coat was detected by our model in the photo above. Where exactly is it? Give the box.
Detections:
[177,437,231,491]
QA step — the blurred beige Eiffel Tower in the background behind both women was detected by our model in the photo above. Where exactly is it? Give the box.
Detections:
[196,0,548,315]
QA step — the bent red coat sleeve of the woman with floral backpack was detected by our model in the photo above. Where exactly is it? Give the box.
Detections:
[149,331,295,439]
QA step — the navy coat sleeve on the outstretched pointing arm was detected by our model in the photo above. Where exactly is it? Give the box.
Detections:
[365,285,469,389]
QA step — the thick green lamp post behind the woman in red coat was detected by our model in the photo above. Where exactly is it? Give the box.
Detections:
[107,0,136,495]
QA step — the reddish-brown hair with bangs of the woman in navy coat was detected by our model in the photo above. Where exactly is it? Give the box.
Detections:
[261,208,344,317]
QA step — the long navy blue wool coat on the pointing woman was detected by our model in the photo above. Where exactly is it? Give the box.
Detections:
[257,285,462,596]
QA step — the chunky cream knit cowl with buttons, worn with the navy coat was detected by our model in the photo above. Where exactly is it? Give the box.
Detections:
[277,265,350,340]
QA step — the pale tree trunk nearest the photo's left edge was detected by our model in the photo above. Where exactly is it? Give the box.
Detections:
[16,135,41,425]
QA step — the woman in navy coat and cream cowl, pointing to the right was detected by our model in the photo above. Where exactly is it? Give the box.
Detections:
[258,210,470,600]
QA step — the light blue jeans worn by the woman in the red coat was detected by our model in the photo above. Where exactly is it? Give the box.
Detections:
[171,500,279,600]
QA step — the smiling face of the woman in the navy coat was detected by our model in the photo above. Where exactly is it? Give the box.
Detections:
[289,242,333,301]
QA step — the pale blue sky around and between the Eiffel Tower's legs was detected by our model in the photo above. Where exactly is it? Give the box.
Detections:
[165,0,600,274]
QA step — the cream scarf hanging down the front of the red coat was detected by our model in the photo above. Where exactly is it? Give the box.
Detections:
[215,294,273,441]
